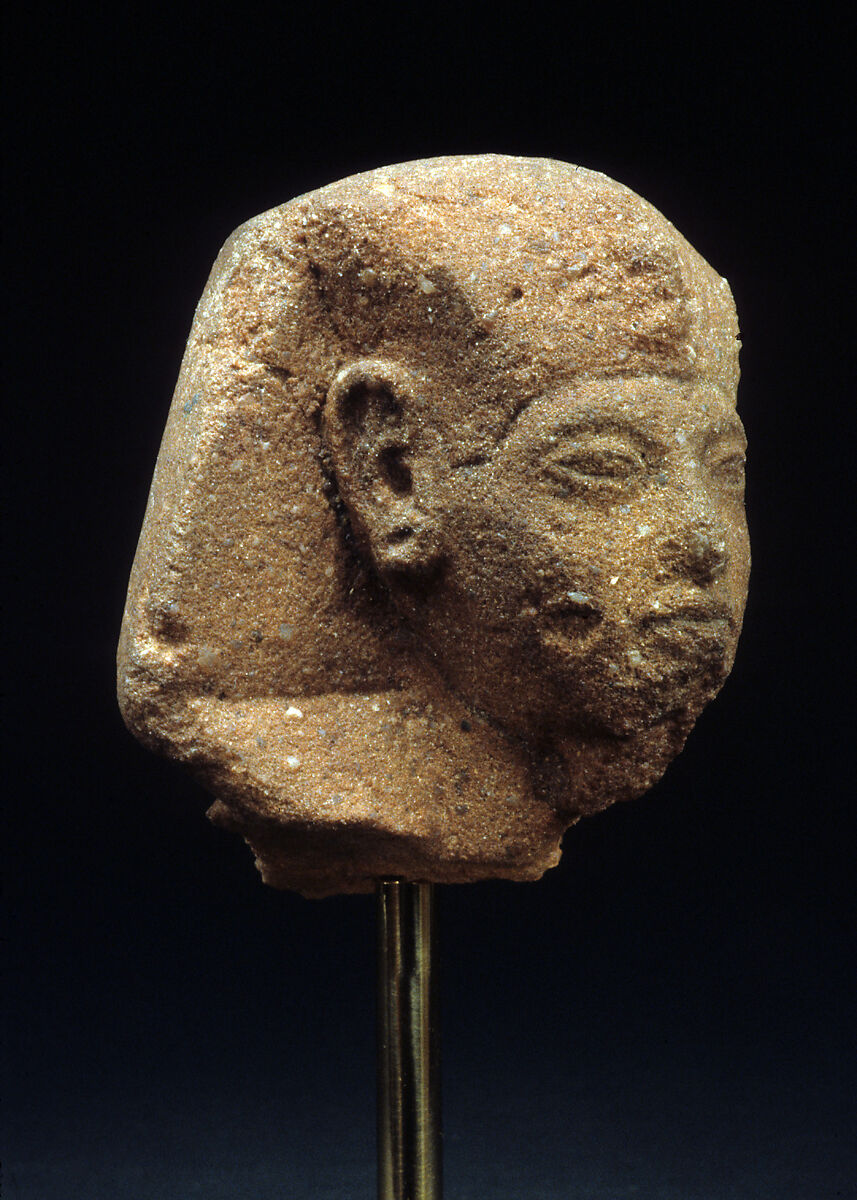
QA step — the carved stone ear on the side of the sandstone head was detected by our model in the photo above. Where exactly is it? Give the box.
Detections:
[322,359,439,577]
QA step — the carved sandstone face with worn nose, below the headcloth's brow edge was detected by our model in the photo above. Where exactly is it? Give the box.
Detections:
[331,364,749,740]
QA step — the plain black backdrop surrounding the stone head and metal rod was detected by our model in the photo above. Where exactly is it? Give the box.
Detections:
[2,4,857,1200]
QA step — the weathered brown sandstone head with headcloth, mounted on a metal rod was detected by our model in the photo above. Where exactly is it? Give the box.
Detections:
[119,155,749,895]
